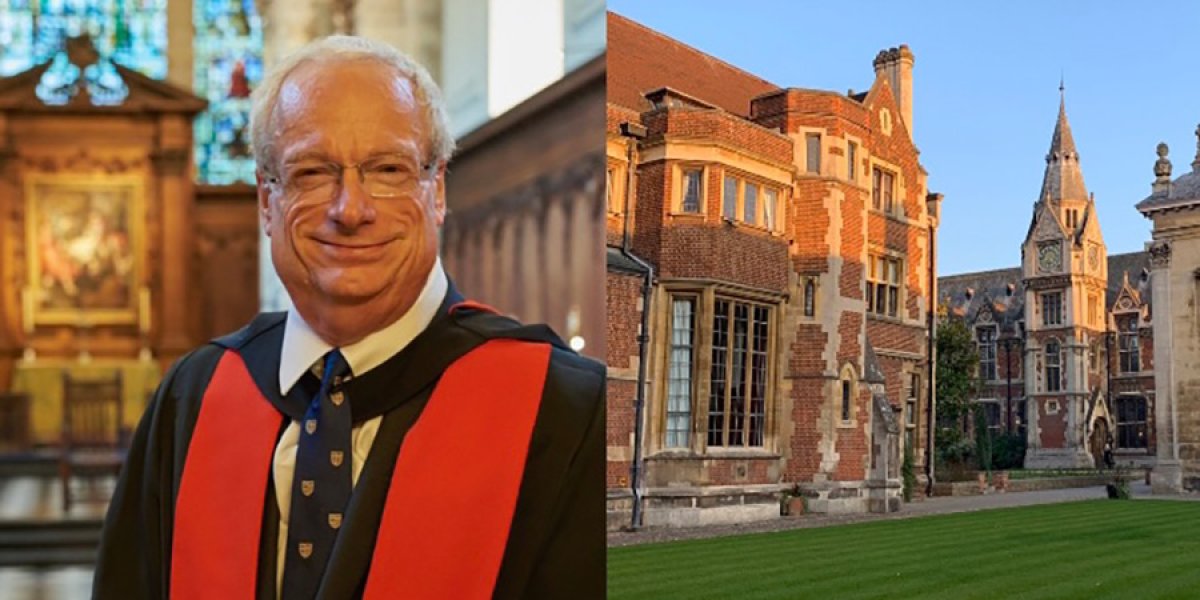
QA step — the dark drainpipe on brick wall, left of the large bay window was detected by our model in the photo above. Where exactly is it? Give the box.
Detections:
[620,122,654,530]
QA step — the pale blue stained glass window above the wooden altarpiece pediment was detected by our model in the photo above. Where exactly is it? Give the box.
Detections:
[0,0,167,104]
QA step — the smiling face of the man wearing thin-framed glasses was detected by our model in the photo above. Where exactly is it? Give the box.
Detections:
[258,60,445,319]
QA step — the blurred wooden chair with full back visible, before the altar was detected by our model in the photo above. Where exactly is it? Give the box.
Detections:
[59,371,126,514]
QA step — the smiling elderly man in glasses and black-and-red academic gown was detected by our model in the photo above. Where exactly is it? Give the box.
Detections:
[95,37,605,600]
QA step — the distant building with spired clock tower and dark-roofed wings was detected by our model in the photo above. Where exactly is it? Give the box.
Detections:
[938,94,1156,468]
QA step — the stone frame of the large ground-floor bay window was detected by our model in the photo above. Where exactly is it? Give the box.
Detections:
[652,281,786,456]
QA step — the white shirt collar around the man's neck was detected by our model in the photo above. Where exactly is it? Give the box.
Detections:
[280,258,449,395]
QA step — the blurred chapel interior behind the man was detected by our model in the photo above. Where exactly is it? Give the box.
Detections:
[0,0,605,599]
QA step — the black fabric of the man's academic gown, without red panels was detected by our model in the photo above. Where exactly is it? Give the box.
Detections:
[92,288,605,600]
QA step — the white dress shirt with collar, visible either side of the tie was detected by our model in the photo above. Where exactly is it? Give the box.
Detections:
[272,258,449,598]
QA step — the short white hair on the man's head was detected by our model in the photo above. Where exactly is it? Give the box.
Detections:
[250,35,455,170]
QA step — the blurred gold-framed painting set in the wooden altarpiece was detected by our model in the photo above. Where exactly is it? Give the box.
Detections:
[25,175,145,326]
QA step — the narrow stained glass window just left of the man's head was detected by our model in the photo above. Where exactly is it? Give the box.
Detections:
[193,0,263,184]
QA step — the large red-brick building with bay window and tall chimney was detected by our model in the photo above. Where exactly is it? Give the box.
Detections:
[606,13,940,526]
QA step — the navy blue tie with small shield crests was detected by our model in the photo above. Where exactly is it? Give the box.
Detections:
[282,349,353,600]
